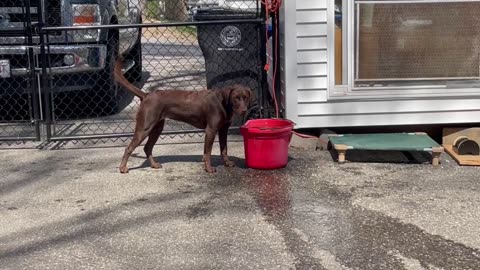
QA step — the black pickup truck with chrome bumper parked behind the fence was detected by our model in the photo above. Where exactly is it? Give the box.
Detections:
[0,0,144,118]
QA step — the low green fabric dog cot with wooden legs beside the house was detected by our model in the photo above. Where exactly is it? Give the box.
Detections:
[330,133,444,166]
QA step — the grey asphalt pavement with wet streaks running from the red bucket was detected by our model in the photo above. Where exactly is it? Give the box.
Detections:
[0,136,480,269]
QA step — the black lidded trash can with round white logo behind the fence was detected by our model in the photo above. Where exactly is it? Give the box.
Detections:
[193,7,265,103]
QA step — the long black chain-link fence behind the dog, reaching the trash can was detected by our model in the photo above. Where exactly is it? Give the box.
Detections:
[0,0,266,146]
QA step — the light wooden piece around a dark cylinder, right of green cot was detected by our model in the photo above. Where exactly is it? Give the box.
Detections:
[442,127,480,166]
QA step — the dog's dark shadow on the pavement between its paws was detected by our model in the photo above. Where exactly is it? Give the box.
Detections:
[129,154,247,170]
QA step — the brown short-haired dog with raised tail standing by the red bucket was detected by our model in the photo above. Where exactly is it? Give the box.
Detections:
[115,58,251,173]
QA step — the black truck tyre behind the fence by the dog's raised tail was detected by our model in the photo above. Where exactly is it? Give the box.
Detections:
[97,32,119,115]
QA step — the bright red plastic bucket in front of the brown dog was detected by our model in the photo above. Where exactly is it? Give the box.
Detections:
[240,119,294,170]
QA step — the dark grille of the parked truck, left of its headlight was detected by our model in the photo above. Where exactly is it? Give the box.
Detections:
[0,0,61,37]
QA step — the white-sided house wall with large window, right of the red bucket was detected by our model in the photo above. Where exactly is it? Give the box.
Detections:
[278,0,480,128]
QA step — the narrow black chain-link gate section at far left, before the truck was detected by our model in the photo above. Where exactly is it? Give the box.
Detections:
[0,0,42,143]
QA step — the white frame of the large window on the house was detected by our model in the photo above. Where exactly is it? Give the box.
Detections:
[327,0,480,100]
